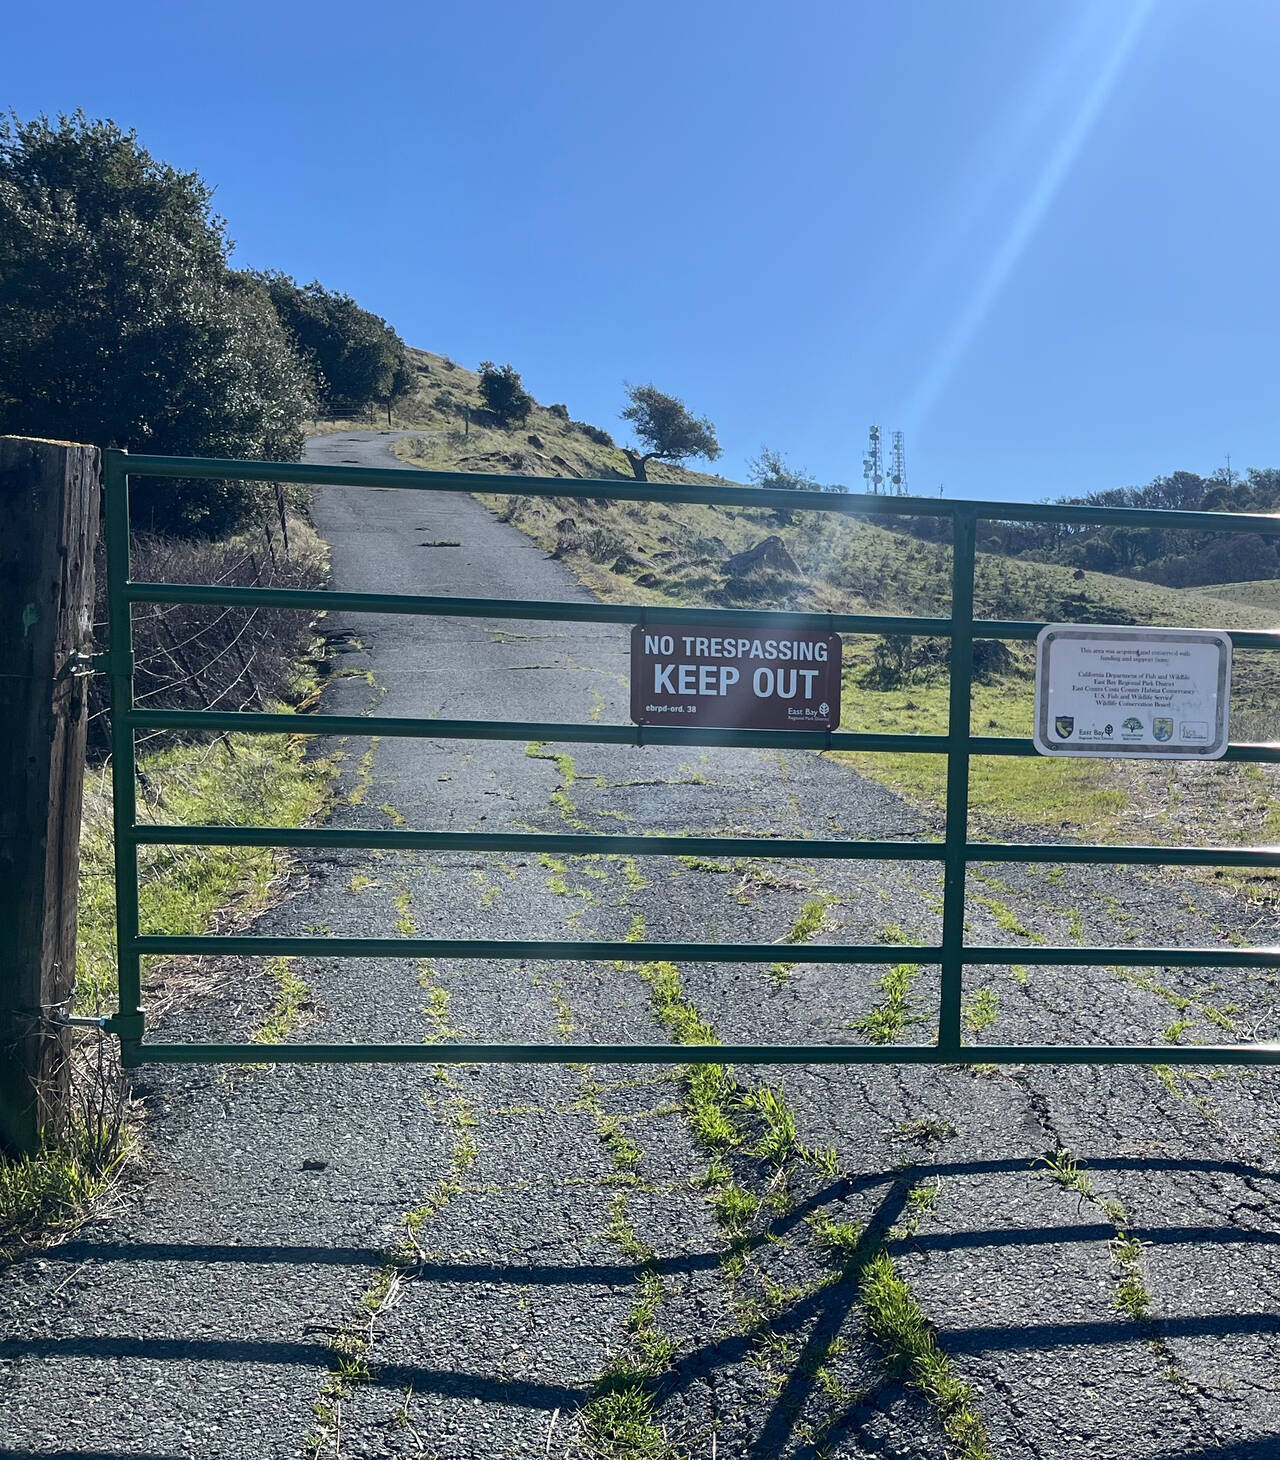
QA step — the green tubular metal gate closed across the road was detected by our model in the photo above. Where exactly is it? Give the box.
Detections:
[104,451,1280,1066]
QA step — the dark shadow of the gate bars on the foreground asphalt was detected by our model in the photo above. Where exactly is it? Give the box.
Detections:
[0,1158,1280,1460]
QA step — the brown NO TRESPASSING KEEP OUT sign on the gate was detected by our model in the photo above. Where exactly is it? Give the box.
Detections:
[631,623,841,730]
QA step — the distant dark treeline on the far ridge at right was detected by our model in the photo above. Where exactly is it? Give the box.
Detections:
[905,467,1280,588]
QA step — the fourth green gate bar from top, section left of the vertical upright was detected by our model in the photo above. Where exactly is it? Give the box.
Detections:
[134,825,945,861]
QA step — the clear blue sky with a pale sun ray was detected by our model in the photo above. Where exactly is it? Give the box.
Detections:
[0,0,1280,499]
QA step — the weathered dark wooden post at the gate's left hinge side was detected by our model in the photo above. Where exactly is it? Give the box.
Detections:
[0,437,101,1155]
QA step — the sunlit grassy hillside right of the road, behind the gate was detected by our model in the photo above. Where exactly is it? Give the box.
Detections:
[397,356,1280,887]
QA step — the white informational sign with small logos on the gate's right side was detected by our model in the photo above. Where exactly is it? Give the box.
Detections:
[1035,623,1230,761]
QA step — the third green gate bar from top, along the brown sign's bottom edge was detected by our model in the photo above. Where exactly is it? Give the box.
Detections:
[123,710,1280,762]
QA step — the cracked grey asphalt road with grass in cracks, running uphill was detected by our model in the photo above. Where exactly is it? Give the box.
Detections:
[0,432,1280,1460]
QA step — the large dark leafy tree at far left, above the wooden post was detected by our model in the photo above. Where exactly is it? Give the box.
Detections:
[0,112,314,534]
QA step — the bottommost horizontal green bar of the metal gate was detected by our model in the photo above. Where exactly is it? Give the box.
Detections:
[124,1042,1280,1066]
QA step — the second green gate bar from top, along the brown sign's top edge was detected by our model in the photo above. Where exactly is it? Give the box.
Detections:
[124,583,1280,650]
